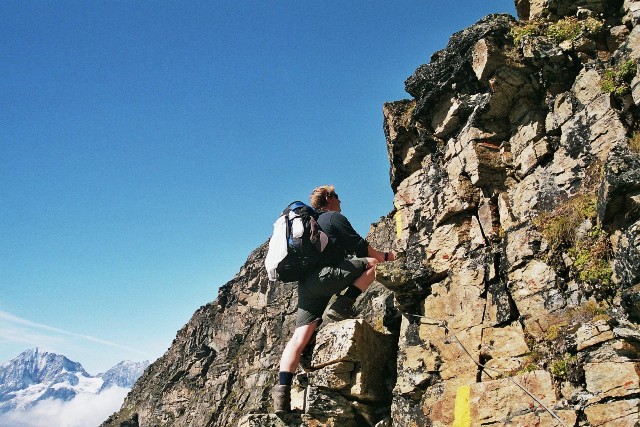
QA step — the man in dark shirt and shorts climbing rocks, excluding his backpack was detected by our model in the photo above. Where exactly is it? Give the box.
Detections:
[272,185,395,414]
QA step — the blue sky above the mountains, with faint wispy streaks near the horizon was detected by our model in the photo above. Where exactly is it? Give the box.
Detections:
[0,0,515,374]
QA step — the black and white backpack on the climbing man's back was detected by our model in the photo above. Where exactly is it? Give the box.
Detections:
[264,201,329,282]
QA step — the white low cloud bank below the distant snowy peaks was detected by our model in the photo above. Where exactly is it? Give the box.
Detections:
[0,387,129,427]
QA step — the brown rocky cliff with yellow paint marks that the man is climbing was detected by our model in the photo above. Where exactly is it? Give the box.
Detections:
[103,0,640,427]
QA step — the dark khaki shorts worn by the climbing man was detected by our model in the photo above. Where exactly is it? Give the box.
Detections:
[296,258,369,327]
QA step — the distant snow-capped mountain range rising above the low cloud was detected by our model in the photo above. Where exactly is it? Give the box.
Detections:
[0,348,149,414]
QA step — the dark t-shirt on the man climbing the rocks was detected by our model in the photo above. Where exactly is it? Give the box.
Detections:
[318,211,369,266]
